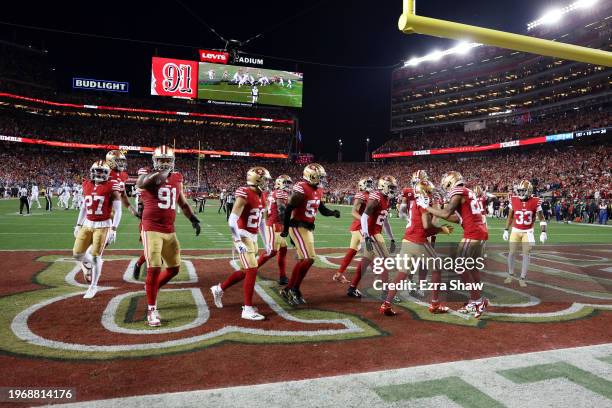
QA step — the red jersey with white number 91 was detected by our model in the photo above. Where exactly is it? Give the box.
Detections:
[140,172,183,234]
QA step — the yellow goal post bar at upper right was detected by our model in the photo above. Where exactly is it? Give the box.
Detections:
[398,0,612,67]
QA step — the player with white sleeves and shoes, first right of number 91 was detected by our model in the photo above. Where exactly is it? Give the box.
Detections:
[210,166,272,320]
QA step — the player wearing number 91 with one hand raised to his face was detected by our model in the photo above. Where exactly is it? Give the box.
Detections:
[136,146,200,326]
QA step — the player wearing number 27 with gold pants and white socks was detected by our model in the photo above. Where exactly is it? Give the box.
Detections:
[72,160,121,299]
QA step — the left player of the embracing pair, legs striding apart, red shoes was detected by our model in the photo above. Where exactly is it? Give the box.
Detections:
[379,181,453,316]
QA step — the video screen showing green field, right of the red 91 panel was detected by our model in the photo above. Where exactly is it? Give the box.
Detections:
[198,62,304,108]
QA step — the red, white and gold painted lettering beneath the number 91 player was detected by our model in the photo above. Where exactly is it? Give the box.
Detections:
[0,255,383,359]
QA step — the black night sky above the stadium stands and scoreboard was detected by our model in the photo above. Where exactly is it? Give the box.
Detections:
[0,0,556,160]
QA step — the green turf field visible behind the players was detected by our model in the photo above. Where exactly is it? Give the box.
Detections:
[0,200,612,250]
